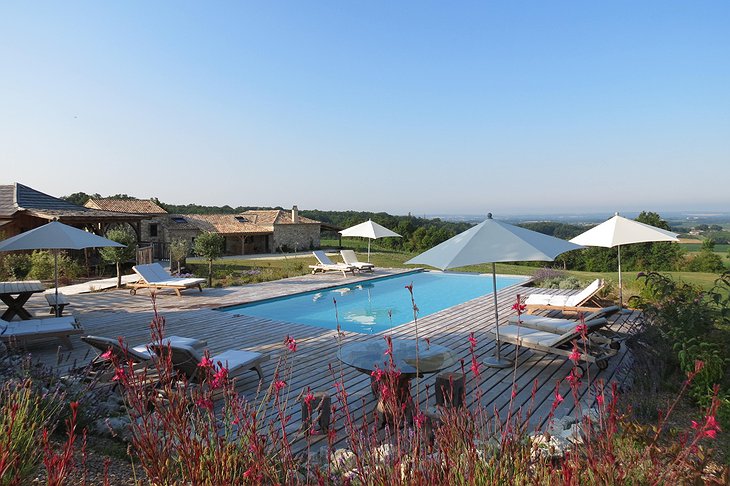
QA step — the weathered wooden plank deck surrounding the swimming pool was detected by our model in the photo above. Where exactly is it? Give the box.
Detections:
[12,269,636,456]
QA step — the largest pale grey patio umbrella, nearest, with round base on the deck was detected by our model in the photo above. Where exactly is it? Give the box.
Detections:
[406,213,582,368]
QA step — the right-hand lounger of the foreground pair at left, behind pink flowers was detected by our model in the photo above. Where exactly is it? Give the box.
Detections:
[152,343,269,382]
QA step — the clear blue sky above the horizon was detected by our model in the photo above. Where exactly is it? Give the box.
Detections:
[0,0,730,216]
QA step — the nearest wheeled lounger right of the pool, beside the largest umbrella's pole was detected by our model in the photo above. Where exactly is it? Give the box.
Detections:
[492,317,618,370]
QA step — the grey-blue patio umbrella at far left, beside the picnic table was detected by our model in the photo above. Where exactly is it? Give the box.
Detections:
[0,221,125,316]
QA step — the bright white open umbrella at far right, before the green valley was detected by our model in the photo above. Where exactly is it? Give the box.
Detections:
[570,213,679,307]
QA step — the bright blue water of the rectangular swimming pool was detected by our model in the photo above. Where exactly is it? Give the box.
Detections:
[220,272,525,334]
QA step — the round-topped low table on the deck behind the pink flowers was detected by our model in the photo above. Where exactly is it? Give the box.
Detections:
[337,337,457,426]
